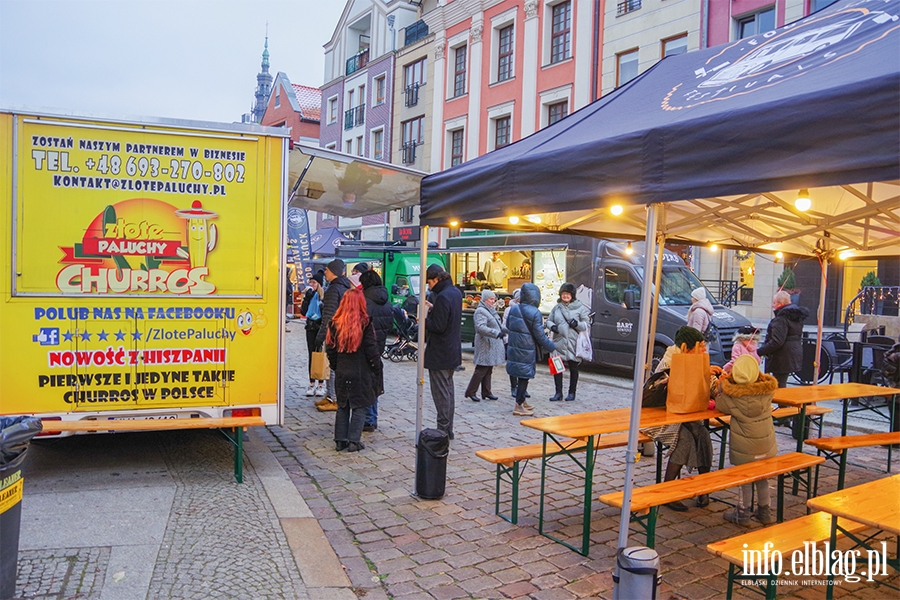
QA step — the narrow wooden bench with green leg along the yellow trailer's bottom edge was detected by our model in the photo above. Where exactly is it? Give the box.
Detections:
[41,417,266,483]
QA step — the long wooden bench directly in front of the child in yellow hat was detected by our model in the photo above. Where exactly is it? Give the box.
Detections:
[599,452,825,548]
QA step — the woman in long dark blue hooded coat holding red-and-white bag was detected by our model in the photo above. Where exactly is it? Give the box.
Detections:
[506,283,556,417]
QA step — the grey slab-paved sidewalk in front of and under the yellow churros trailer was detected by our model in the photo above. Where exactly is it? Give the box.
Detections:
[17,430,356,600]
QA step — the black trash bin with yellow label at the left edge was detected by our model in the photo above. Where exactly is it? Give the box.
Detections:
[0,417,41,600]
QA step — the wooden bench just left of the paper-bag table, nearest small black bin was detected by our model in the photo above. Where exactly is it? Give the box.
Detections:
[475,433,650,524]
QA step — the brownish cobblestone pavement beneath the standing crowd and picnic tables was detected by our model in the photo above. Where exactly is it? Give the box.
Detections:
[264,324,898,600]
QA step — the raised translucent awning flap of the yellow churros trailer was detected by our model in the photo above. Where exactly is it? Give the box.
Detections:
[289,144,425,217]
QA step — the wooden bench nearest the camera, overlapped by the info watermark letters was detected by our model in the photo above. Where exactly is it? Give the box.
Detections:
[706,512,867,600]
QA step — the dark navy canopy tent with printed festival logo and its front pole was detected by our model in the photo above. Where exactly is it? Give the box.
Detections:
[421,0,900,568]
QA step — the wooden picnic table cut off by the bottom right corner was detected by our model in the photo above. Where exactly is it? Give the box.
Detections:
[806,475,900,600]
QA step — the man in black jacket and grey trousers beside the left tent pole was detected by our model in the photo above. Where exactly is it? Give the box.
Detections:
[425,265,462,440]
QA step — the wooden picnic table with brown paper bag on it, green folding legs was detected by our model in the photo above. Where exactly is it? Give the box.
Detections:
[520,408,725,556]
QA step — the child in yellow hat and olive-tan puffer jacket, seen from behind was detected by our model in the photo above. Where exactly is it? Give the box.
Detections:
[716,354,778,526]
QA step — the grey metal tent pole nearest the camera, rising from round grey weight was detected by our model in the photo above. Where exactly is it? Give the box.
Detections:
[614,204,659,584]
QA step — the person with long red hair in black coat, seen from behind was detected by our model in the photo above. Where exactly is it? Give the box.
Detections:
[325,289,384,452]
